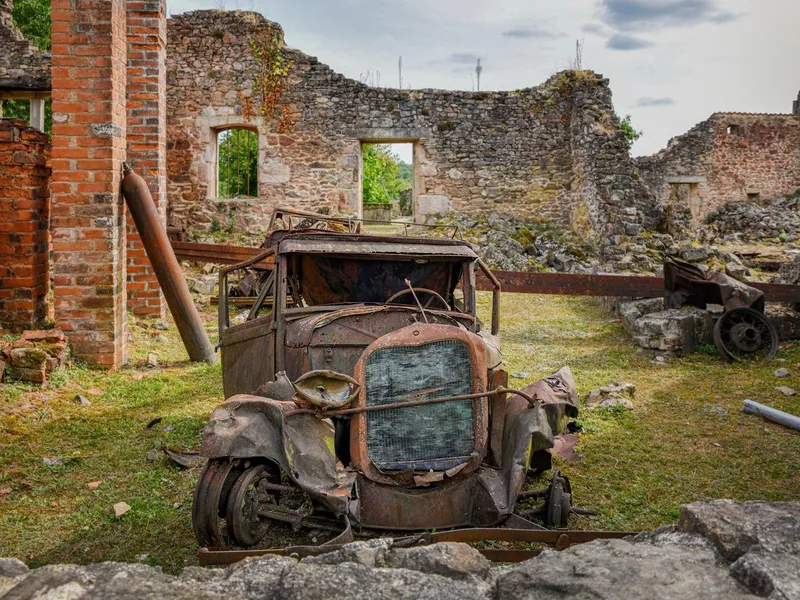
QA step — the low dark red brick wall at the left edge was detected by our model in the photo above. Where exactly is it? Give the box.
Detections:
[0,119,50,328]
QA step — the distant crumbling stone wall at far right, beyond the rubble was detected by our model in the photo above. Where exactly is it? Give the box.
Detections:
[636,113,800,228]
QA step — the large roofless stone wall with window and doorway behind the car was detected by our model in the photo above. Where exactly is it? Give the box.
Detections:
[167,11,653,245]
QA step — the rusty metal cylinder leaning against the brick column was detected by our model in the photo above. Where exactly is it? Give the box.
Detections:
[122,164,217,363]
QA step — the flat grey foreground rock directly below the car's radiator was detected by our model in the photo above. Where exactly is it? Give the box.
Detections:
[385,542,492,581]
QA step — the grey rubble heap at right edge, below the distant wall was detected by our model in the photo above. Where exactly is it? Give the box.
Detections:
[705,195,800,243]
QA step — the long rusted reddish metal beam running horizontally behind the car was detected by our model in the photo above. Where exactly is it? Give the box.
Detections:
[173,242,800,303]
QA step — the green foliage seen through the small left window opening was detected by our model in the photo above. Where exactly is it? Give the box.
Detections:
[217,129,258,198]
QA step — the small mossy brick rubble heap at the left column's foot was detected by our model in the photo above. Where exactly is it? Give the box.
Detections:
[0,329,67,383]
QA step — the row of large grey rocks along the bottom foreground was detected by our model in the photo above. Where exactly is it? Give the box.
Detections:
[0,500,800,600]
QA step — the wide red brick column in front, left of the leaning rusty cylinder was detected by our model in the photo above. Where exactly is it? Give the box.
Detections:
[51,0,127,368]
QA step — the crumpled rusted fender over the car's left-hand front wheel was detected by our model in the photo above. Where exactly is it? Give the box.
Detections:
[200,394,355,514]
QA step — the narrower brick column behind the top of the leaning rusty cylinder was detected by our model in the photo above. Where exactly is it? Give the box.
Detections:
[126,0,167,317]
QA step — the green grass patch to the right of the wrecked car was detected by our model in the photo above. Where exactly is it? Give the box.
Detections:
[481,294,800,530]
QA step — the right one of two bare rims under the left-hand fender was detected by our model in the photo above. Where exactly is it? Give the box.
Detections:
[225,464,270,546]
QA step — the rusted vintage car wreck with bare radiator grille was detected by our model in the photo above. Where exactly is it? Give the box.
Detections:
[193,210,578,549]
